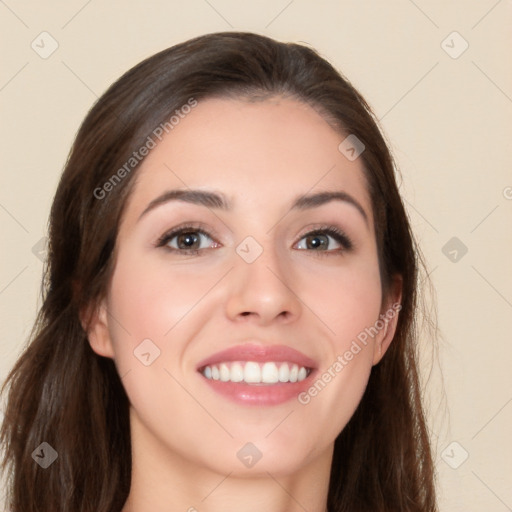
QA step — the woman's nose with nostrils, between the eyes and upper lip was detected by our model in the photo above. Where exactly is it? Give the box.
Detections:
[226,239,302,325]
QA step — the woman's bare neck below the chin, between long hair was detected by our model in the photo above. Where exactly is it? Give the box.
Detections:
[122,410,332,512]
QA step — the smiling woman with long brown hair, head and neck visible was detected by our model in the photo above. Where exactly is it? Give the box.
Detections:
[1,32,437,512]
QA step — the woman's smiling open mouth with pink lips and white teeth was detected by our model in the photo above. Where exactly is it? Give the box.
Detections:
[197,344,317,406]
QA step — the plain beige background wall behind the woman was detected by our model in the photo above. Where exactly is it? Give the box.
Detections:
[0,0,512,512]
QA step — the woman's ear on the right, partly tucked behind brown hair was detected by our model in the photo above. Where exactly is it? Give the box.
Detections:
[373,275,403,366]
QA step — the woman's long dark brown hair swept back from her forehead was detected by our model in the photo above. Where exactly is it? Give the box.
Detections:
[0,32,437,512]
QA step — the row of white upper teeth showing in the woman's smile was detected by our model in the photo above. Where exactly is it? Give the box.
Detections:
[202,361,309,384]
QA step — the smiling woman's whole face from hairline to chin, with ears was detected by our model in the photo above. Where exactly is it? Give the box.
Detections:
[89,98,397,475]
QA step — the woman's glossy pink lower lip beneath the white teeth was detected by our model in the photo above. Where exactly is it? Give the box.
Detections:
[199,370,316,406]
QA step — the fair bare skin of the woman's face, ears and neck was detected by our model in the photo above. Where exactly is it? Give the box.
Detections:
[89,97,400,512]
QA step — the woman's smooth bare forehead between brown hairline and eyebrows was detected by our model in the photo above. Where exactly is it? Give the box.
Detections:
[122,97,371,224]
